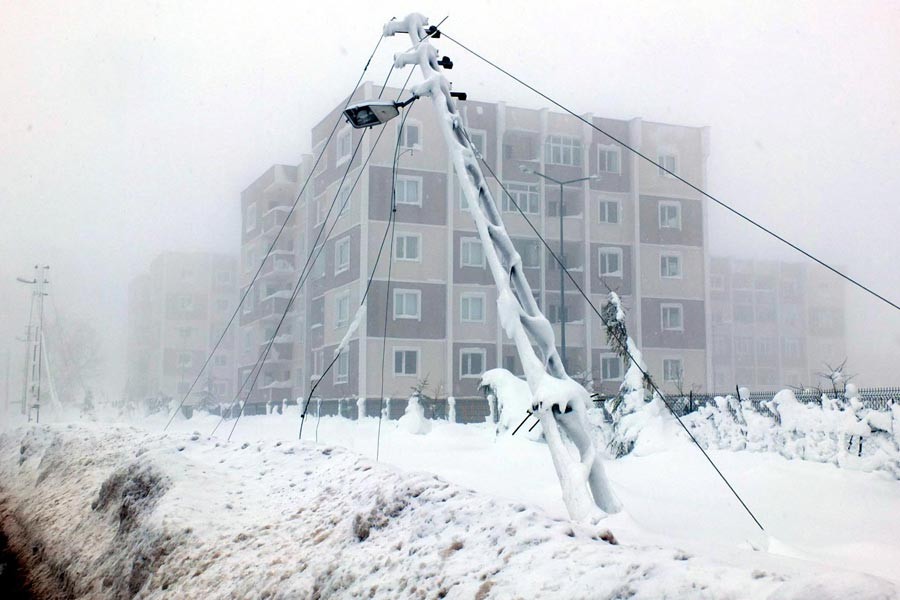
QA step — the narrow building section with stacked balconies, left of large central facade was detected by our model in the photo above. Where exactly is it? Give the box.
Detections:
[238,165,308,414]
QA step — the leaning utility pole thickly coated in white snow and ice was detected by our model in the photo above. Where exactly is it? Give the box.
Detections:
[378,13,620,522]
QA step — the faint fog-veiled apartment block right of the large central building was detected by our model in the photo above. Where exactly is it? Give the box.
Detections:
[709,257,846,391]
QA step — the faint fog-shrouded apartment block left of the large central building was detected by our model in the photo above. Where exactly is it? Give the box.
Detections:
[127,252,237,406]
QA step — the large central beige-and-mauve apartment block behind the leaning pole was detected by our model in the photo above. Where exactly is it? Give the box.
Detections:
[242,84,708,410]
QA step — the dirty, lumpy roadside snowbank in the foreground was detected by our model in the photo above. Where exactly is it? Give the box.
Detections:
[0,417,897,598]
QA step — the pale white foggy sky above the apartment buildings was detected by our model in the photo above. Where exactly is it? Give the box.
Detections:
[0,0,900,397]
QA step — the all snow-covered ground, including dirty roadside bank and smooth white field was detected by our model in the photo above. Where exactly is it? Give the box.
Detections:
[0,409,900,598]
